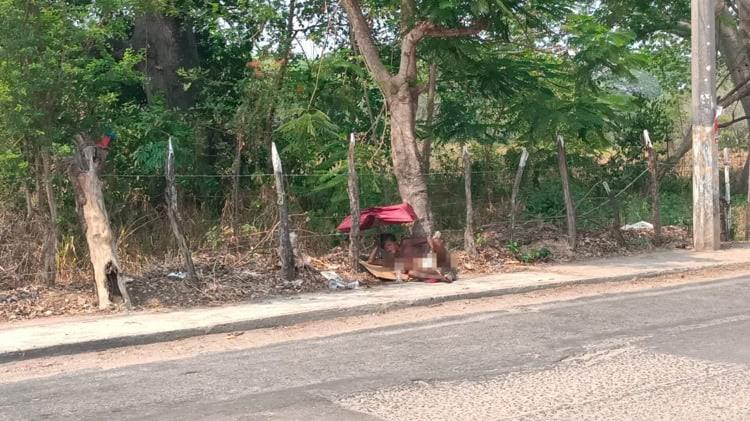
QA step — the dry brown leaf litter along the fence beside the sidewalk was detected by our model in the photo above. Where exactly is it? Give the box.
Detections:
[0,224,688,322]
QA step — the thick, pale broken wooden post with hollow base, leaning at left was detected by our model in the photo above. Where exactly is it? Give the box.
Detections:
[66,135,122,309]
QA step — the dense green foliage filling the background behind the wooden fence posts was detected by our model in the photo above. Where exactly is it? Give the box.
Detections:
[0,0,700,261]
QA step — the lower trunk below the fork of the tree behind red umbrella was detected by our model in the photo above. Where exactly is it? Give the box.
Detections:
[388,93,433,237]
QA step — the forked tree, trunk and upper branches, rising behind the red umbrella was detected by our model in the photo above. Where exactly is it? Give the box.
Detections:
[342,0,567,233]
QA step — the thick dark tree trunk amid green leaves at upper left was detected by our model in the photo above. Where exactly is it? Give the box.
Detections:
[131,13,200,110]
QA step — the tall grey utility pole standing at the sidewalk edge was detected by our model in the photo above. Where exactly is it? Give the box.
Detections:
[690,0,721,251]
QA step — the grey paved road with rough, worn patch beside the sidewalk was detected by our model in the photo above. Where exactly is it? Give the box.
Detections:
[0,278,750,421]
